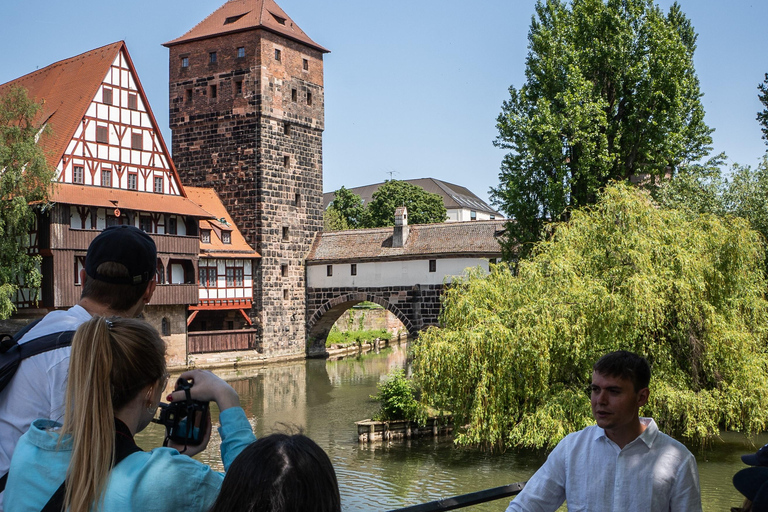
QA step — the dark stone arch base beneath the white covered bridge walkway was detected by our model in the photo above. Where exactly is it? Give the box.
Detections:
[307,284,443,356]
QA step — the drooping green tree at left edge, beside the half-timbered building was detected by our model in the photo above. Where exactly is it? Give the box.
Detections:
[0,88,54,318]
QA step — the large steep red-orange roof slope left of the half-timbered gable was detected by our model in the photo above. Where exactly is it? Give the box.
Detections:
[0,41,125,168]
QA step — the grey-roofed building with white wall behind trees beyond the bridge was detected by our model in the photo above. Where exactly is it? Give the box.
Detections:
[323,178,504,222]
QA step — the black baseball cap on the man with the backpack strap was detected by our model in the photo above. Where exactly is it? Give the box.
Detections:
[85,226,157,285]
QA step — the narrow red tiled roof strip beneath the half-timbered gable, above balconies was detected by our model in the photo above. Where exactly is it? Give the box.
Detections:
[49,183,212,218]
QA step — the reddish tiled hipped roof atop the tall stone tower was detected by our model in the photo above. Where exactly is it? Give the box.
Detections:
[163,0,329,53]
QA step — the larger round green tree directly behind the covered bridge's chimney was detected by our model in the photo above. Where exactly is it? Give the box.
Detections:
[363,180,447,228]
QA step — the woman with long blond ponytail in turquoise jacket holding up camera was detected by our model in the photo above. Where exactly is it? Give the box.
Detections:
[5,317,255,512]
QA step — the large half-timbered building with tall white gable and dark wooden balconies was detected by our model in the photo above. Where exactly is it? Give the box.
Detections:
[0,41,210,363]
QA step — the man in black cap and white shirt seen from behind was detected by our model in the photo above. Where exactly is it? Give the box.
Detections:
[0,226,157,512]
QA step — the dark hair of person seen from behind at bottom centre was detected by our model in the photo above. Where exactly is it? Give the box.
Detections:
[209,434,341,512]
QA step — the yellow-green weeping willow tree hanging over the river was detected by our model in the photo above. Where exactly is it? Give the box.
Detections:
[414,185,768,449]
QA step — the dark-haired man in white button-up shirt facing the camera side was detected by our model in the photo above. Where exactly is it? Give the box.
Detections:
[507,350,701,512]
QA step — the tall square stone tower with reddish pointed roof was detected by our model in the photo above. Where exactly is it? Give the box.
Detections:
[164,0,328,356]
